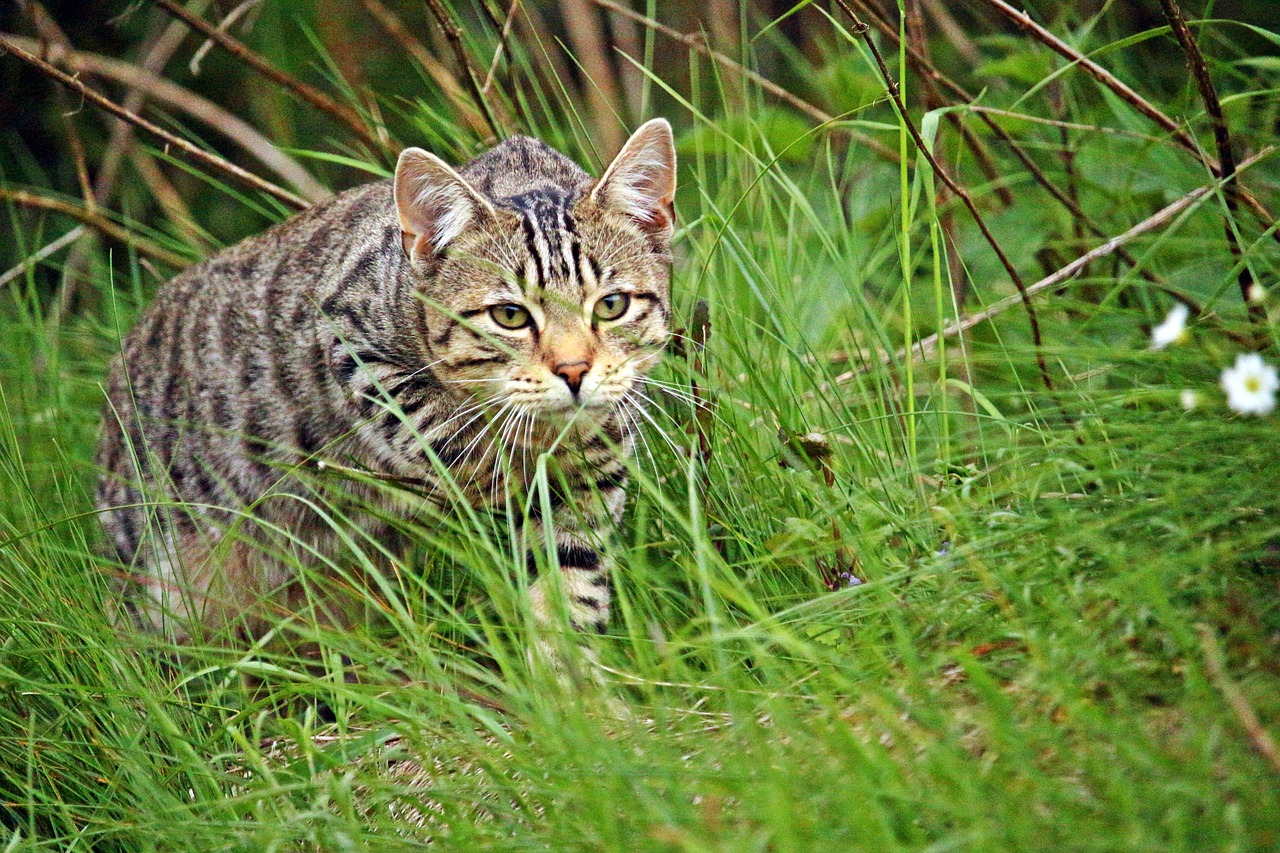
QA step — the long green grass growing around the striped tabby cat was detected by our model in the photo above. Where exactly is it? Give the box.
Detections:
[0,3,1280,850]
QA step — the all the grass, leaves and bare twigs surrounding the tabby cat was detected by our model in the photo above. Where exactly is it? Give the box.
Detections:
[0,0,1280,850]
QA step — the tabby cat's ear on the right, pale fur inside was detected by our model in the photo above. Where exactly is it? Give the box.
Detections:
[591,119,676,242]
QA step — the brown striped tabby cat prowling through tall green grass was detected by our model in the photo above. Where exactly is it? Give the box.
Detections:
[96,119,676,643]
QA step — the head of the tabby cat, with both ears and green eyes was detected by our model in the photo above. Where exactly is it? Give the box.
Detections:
[396,119,676,432]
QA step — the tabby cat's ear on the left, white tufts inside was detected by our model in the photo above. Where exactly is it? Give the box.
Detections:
[396,149,497,260]
